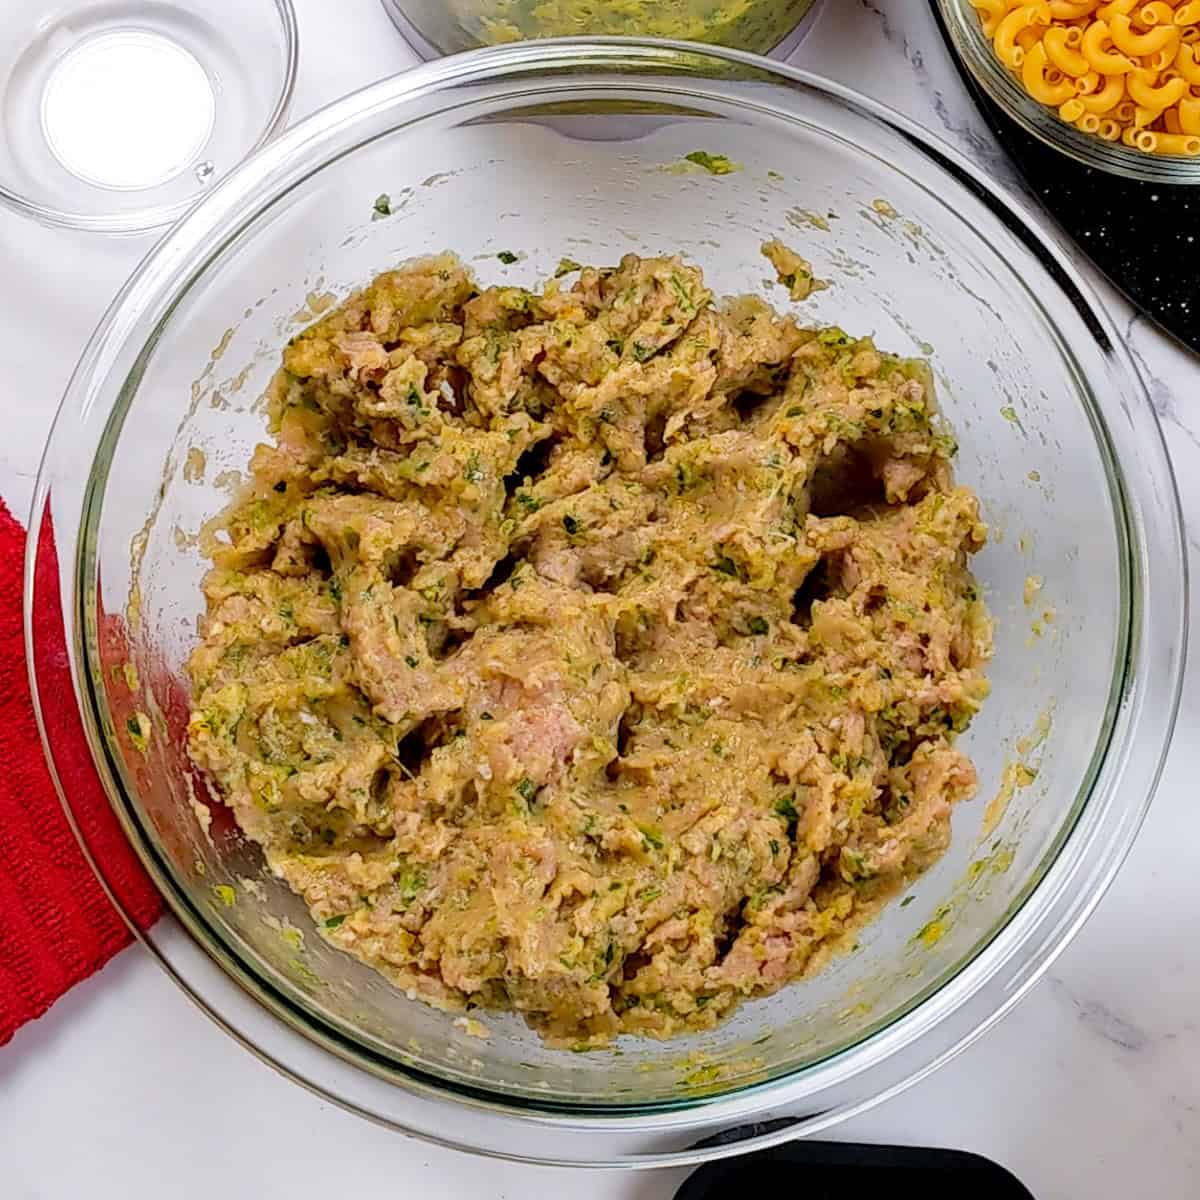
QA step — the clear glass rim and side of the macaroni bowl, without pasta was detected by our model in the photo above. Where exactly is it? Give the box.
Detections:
[937,0,1200,184]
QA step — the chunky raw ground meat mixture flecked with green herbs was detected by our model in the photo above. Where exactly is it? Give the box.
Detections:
[191,247,991,1045]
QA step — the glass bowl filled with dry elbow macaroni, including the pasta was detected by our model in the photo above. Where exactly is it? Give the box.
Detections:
[938,0,1200,184]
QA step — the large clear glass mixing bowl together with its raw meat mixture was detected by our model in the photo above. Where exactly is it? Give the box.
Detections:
[31,42,1184,1164]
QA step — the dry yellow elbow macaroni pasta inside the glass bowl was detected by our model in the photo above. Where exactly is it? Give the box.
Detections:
[970,0,1200,156]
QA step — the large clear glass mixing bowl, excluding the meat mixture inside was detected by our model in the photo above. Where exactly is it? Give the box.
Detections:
[29,41,1186,1165]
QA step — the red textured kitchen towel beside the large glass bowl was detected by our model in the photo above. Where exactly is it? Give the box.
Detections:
[0,500,161,1045]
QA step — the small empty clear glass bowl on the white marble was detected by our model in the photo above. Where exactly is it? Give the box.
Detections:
[0,0,298,234]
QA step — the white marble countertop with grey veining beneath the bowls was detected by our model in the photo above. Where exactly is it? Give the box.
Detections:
[0,0,1200,1200]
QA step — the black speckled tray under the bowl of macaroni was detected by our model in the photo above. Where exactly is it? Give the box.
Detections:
[934,2,1200,352]
